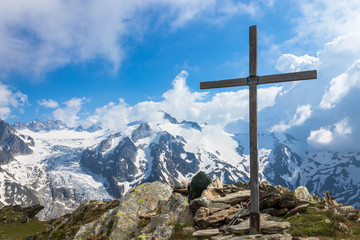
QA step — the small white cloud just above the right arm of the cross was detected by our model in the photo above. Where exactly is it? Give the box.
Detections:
[276,54,319,72]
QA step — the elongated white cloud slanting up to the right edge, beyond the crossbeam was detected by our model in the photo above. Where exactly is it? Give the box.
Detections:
[320,59,360,109]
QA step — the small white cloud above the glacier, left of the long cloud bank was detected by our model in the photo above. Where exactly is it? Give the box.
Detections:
[53,98,85,127]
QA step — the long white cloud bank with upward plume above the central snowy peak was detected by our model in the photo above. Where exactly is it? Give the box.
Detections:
[82,71,282,129]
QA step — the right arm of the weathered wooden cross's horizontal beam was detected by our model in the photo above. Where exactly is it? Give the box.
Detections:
[259,70,317,84]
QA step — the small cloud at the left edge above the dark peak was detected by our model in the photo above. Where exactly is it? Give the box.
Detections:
[0,82,28,120]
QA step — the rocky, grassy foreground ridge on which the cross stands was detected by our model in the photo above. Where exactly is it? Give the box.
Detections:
[0,179,360,240]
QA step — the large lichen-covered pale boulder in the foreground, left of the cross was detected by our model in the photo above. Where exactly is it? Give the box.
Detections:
[74,182,174,240]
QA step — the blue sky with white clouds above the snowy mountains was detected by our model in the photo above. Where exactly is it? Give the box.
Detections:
[0,0,360,151]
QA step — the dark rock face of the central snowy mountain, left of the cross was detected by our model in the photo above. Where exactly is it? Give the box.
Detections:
[80,123,199,197]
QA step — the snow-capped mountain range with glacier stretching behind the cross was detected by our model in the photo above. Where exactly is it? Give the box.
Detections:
[0,113,360,219]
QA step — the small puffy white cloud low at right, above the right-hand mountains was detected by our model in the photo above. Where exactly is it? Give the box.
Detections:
[307,118,352,149]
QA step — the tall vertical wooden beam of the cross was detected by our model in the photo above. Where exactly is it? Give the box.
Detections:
[249,26,261,234]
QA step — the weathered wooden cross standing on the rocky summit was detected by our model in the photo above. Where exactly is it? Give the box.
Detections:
[200,26,317,234]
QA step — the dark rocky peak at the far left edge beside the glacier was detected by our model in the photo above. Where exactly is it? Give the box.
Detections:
[0,120,35,164]
